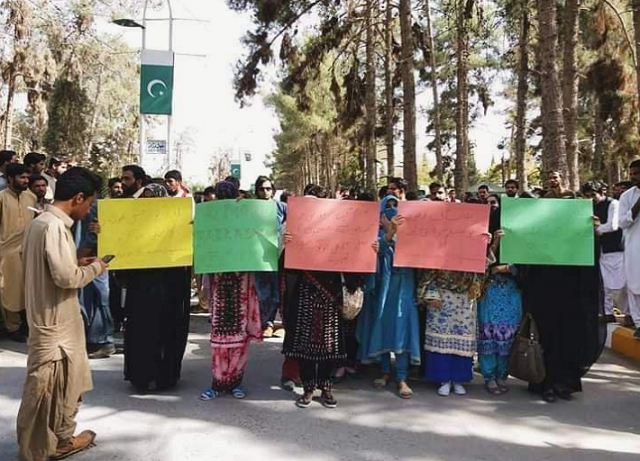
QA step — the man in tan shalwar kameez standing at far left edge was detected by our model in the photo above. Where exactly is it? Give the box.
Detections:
[0,163,37,343]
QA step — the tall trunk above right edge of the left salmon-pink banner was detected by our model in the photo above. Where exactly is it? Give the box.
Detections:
[364,0,378,191]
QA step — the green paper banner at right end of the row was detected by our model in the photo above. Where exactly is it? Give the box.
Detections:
[500,197,595,266]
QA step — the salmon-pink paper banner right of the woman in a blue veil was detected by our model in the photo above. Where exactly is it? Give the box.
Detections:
[394,202,489,273]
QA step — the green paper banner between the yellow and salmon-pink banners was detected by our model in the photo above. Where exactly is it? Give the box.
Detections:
[194,200,279,274]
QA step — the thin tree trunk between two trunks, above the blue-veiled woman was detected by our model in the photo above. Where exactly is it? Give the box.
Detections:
[384,0,396,177]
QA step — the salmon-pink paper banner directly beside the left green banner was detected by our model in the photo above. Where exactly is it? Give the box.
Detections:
[285,197,380,272]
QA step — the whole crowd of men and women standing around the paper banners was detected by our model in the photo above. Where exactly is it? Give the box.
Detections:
[0,146,640,461]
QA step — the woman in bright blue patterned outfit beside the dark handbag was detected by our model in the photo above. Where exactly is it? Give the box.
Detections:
[478,228,522,395]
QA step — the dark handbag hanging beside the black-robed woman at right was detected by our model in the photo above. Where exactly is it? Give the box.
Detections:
[509,313,547,384]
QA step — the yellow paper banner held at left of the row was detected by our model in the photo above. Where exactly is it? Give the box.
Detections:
[98,197,193,270]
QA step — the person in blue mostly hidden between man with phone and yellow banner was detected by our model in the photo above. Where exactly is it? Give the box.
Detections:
[72,200,116,359]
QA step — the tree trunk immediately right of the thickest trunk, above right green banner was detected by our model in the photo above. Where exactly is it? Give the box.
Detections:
[562,0,580,190]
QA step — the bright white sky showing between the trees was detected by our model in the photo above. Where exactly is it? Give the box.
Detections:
[97,0,509,188]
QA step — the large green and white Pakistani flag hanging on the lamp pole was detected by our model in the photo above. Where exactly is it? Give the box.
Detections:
[140,50,173,115]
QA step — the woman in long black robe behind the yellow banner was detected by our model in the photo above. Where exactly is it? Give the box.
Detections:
[115,181,191,392]
